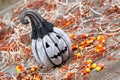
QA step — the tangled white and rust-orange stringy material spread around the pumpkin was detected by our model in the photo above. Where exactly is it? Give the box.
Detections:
[0,0,120,80]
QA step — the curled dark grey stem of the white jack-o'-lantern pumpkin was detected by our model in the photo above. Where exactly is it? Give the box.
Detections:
[20,9,54,39]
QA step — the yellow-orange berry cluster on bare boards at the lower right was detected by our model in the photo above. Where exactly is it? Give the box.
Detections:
[82,59,104,75]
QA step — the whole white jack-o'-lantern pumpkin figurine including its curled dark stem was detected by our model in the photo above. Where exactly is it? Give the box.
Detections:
[20,10,71,67]
